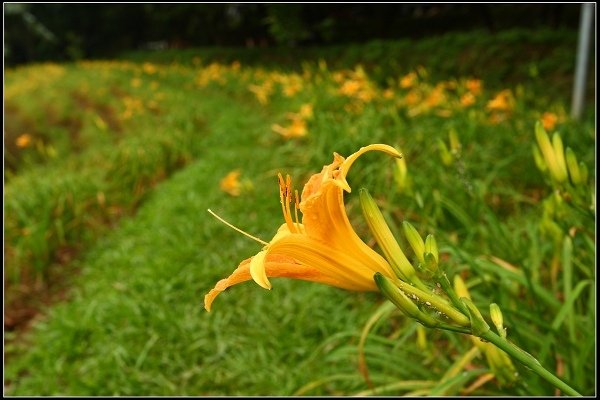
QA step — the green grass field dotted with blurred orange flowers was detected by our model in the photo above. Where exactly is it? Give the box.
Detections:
[4,31,596,396]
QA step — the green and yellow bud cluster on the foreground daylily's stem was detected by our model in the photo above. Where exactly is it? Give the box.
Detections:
[360,189,516,383]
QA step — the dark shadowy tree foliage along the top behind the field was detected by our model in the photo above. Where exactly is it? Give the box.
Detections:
[4,3,580,65]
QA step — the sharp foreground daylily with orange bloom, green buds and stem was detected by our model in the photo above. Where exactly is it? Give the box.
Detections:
[204,144,579,395]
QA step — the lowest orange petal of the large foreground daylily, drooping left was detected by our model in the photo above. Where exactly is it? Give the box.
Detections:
[204,254,354,311]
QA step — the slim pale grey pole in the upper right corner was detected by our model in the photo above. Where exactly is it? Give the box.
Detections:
[571,3,594,119]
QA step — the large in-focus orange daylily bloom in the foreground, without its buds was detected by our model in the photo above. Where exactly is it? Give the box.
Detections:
[204,144,401,311]
